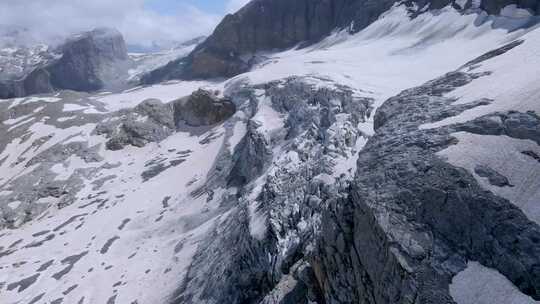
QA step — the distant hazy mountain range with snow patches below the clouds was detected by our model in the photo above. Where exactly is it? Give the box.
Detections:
[0,28,202,99]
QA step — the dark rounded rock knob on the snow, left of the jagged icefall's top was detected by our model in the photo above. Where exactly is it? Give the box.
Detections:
[173,89,236,127]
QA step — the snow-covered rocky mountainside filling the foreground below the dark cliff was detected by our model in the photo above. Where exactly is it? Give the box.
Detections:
[0,0,540,304]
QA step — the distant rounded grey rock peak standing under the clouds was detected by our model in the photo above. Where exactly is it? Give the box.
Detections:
[0,28,128,98]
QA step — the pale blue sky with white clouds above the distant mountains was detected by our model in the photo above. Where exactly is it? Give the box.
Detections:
[0,0,221,46]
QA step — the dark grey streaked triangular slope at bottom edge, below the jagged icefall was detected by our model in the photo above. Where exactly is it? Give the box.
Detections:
[170,204,274,304]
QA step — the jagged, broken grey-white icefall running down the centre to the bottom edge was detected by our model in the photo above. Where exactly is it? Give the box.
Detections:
[171,78,371,304]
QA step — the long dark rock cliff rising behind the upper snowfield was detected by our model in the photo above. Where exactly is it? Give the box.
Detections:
[142,0,540,83]
